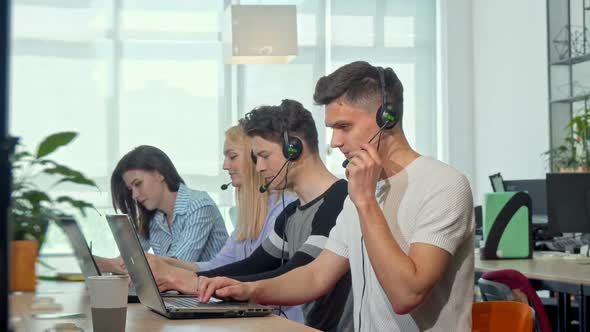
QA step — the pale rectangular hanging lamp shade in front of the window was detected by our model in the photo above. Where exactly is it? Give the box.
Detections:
[223,5,297,64]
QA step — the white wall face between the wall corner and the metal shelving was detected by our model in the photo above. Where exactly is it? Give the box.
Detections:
[473,0,549,205]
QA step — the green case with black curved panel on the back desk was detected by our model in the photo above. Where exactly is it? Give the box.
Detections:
[480,192,533,259]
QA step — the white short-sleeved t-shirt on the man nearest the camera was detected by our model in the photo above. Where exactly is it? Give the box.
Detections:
[326,157,474,331]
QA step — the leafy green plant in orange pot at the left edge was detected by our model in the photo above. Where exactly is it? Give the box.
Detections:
[9,132,98,291]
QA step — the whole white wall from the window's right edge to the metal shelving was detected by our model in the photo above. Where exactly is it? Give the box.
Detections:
[443,0,549,204]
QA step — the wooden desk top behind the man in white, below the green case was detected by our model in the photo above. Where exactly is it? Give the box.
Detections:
[475,252,590,285]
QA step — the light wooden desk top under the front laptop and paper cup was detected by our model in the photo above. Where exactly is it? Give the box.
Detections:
[10,281,317,332]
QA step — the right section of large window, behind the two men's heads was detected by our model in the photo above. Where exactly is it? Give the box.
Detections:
[237,0,437,177]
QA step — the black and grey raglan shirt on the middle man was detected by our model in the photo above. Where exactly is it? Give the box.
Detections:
[199,180,352,331]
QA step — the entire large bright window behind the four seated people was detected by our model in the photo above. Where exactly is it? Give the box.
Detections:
[10,0,436,256]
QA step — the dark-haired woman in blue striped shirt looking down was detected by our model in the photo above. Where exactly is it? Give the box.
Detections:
[99,145,228,272]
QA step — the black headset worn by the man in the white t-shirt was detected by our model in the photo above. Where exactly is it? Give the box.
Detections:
[342,67,404,168]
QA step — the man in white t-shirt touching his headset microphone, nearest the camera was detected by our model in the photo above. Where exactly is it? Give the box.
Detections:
[199,61,474,331]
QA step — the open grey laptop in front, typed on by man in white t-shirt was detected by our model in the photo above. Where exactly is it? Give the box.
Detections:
[107,214,272,319]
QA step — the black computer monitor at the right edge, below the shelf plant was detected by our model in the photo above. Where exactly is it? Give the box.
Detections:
[547,173,590,233]
